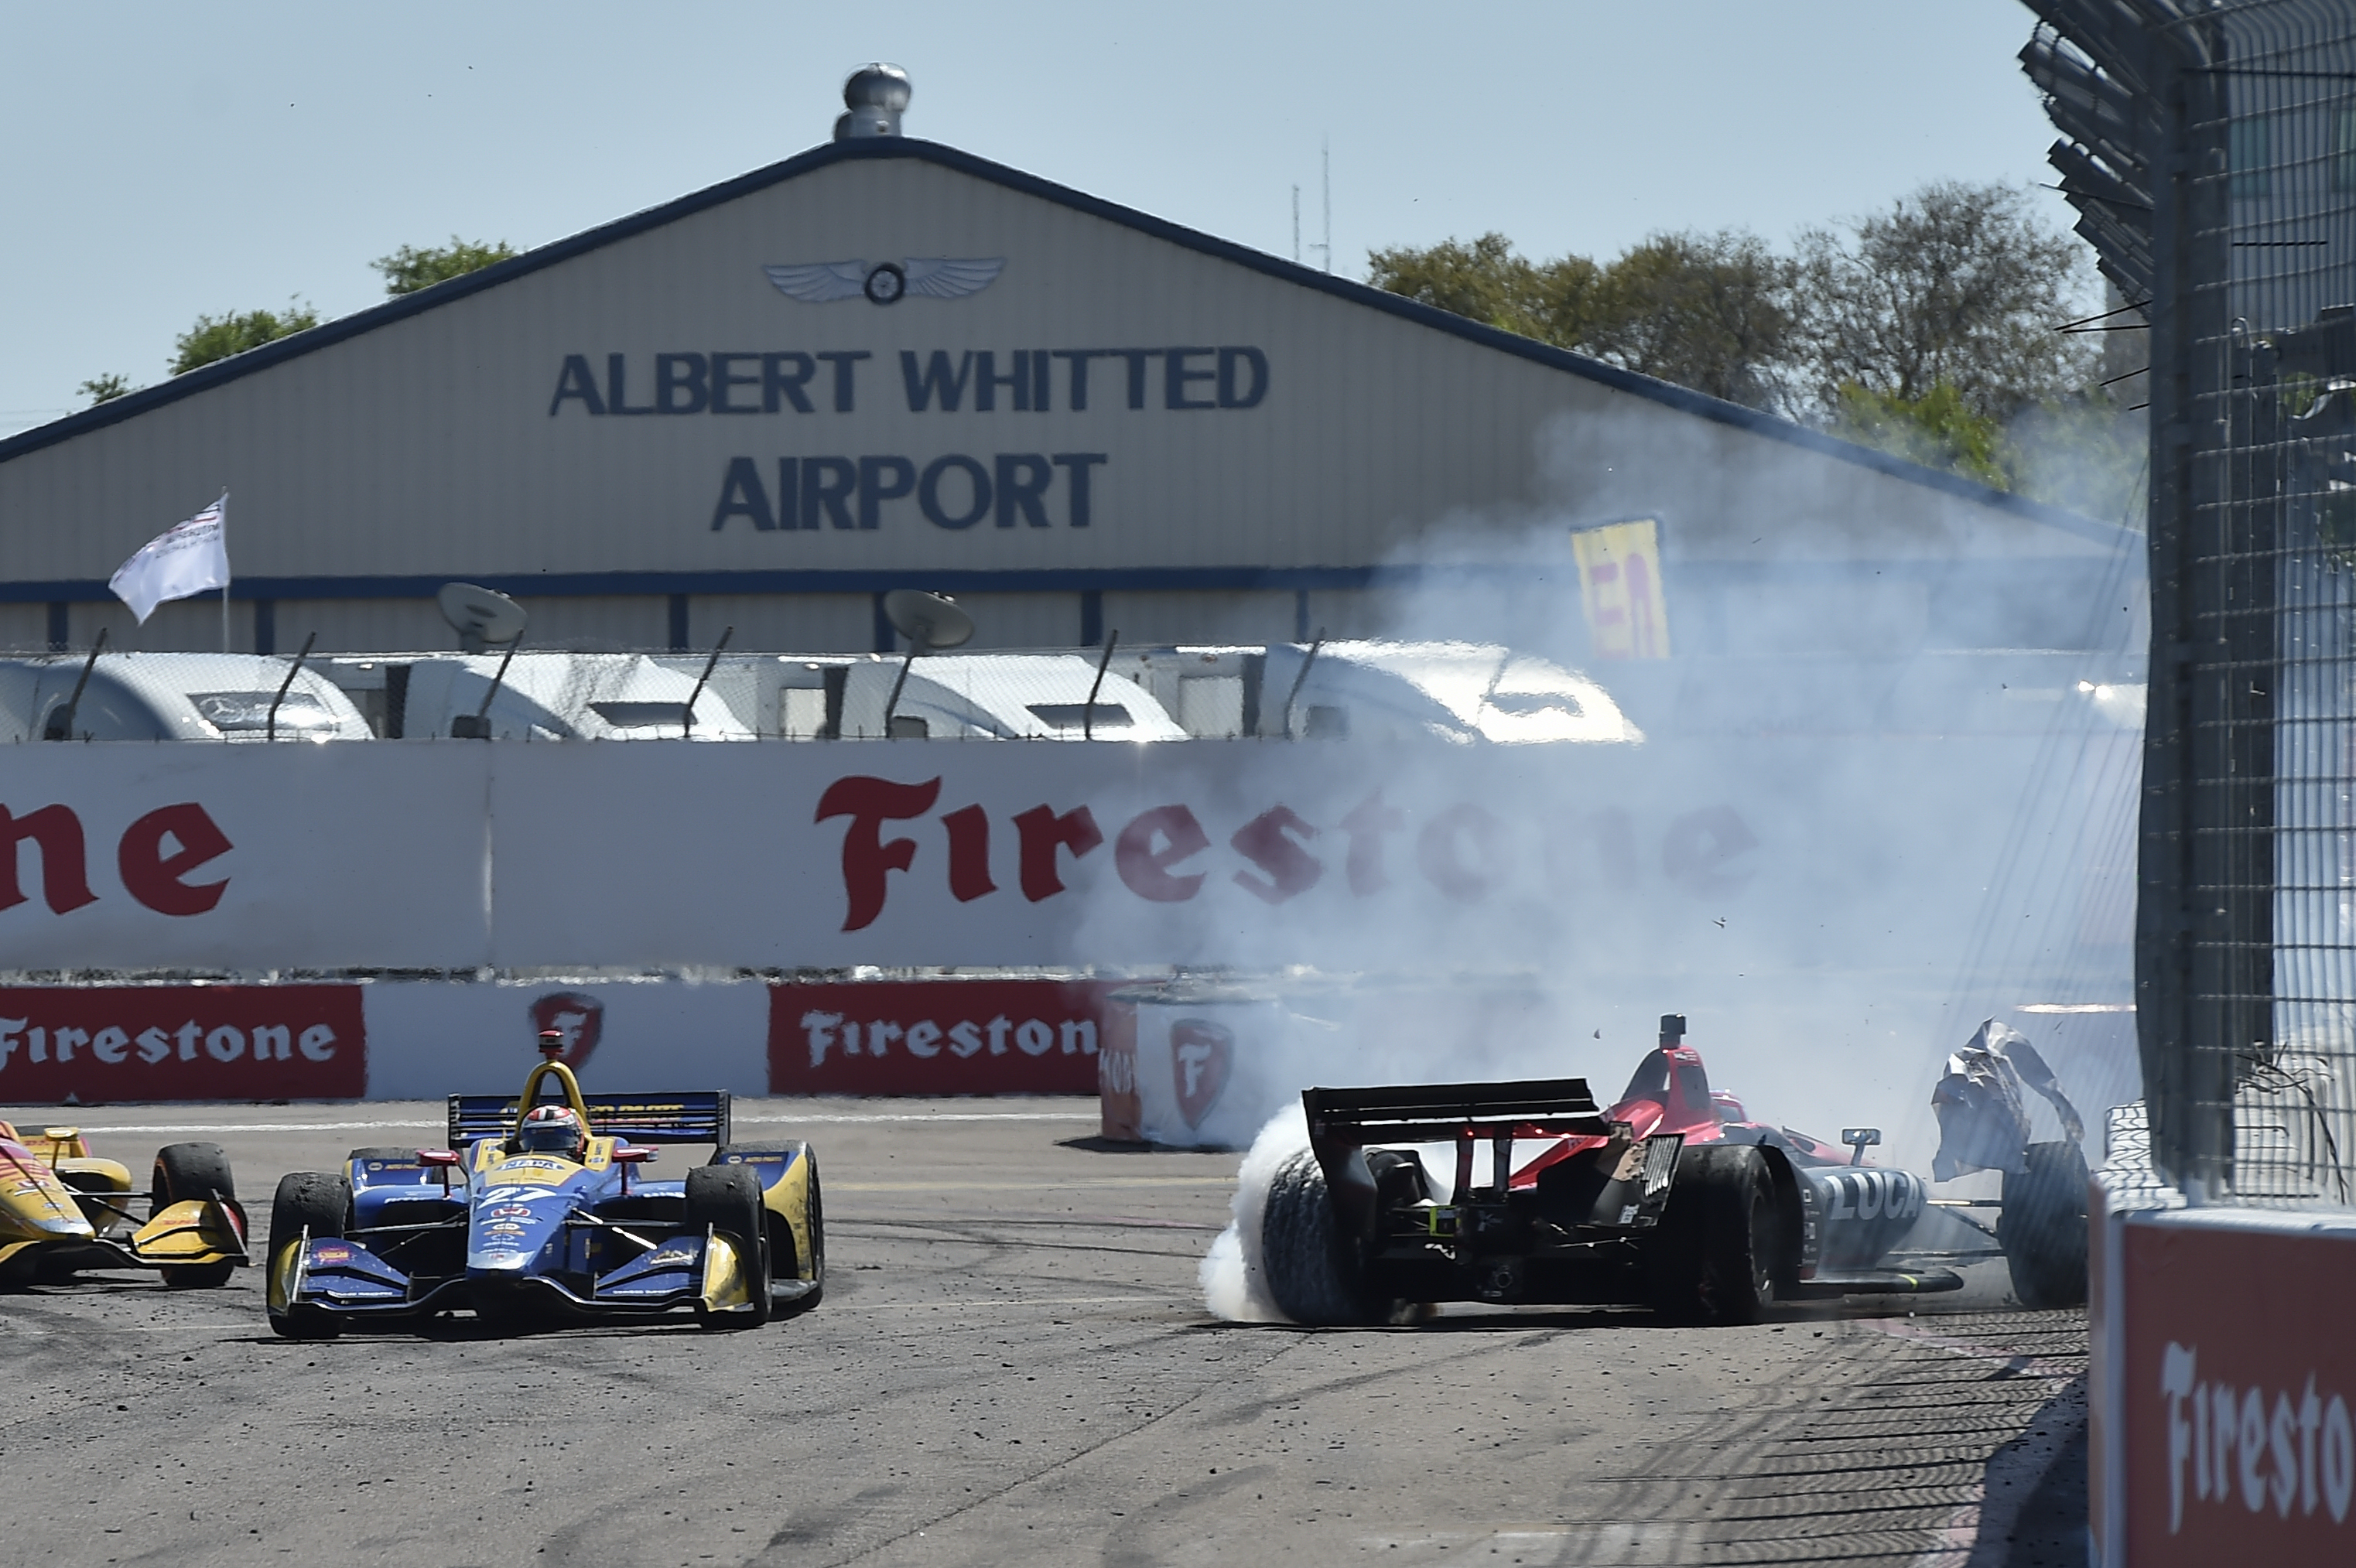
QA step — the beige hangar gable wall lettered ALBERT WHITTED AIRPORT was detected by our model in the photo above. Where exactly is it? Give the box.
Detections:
[0,139,2121,654]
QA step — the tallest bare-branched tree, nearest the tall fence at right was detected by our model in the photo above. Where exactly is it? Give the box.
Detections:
[1797,181,2097,422]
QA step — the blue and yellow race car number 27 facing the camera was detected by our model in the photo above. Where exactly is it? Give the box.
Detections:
[268,1031,827,1340]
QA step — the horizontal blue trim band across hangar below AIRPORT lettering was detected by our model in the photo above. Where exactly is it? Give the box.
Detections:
[0,555,2139,605]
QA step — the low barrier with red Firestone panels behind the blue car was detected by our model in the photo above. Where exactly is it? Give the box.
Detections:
[0,979,1107,1104]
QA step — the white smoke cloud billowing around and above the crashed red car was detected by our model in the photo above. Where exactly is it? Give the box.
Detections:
[1188,405,2146,1320]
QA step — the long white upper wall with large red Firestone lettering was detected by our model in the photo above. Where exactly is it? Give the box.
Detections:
[0,735,2064,979]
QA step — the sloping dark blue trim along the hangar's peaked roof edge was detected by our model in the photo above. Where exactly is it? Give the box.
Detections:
[0,137,2135,546]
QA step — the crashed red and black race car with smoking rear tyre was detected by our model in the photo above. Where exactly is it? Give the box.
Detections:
[1260,1015,2085,1326]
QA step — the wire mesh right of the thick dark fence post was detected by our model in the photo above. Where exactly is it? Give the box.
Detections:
[2182,0,2356,1203]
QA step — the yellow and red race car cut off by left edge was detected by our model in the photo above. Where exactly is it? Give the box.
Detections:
[0,1121,248,1290]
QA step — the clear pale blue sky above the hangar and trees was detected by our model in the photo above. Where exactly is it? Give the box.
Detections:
[0,0,2069,433]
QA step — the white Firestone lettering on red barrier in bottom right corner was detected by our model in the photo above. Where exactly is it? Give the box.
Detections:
[2160,1340,2356,1535]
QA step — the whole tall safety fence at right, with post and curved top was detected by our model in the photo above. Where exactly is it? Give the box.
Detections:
[2024,0,2356,1205]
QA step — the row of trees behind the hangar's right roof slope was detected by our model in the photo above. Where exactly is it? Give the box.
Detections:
[1369,181,2142,516]
